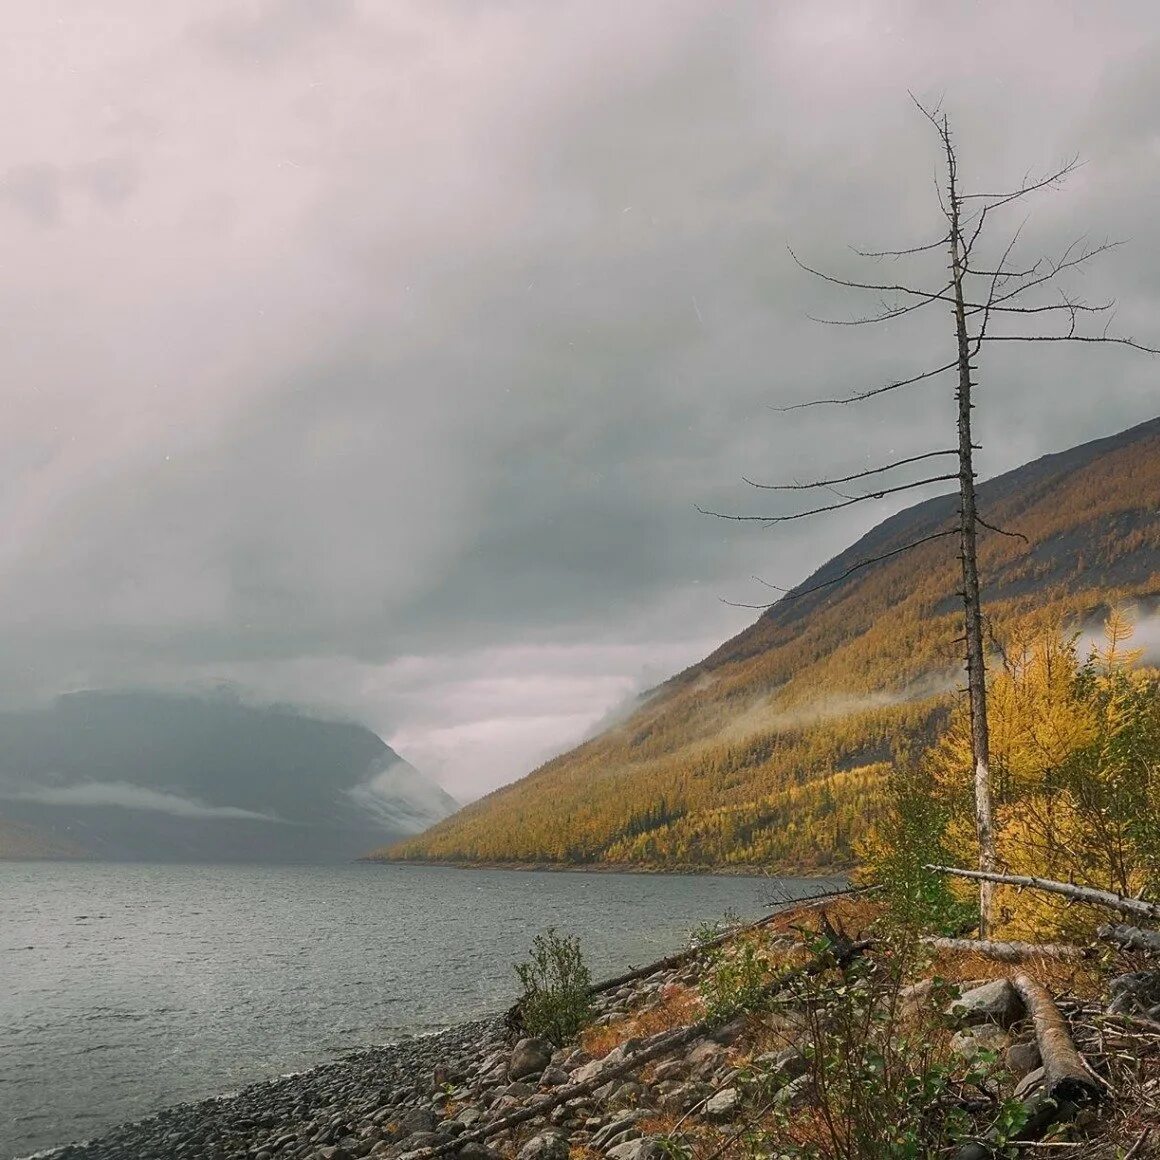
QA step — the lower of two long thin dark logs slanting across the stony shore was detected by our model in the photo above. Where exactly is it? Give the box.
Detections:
[417,940,870,1160]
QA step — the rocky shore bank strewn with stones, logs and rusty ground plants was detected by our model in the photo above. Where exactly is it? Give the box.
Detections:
[31,898,1160,1160]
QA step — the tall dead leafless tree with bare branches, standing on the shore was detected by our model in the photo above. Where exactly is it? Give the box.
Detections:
[702,96,1160,938]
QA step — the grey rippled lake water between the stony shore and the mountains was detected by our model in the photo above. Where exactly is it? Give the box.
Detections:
[0,862,831,1160]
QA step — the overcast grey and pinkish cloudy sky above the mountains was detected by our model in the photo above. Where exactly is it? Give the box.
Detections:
[0,0,1160,799]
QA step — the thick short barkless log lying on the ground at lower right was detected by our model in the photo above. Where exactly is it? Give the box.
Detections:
[955,974,1103,1160]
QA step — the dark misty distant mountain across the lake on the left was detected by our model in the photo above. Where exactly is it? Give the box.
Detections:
[0,693,456,862]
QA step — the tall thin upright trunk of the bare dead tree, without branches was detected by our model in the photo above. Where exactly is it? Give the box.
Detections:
[942,117,996,938]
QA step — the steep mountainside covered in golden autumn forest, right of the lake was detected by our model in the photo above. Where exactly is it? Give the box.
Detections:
[379,419,1160,868]
